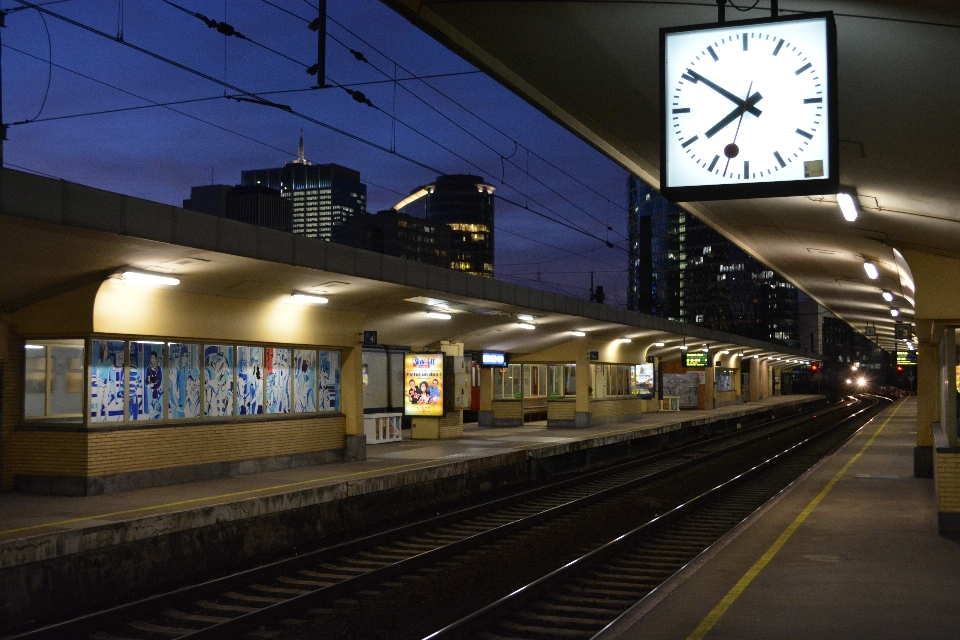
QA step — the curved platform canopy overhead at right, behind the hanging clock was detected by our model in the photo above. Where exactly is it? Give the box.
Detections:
[384,0,960,348]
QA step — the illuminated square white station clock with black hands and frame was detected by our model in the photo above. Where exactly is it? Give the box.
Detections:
[660,13,839,202]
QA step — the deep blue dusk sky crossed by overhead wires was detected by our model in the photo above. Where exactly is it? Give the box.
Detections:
[0,0,627,306]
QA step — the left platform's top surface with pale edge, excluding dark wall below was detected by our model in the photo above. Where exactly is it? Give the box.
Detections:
[0,395,816,569]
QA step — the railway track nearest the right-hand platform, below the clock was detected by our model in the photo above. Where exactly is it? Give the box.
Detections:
[424,392,880,640]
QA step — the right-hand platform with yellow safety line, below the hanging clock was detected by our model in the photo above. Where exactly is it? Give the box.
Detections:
[601,397,960,640]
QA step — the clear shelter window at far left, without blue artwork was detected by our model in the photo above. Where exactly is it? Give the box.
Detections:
[23,340,83,419]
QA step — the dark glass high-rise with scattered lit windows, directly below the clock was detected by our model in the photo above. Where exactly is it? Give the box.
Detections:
[627,176,808,348]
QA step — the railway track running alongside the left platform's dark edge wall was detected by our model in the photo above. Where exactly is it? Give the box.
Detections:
[3,396,857,640]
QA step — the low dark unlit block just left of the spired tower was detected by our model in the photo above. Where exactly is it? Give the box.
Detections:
[183,184,293,232]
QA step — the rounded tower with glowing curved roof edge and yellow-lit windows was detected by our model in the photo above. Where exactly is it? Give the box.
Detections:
[393,175,496,278]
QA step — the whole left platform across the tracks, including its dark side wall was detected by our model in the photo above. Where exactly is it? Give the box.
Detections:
[0,395,823,620]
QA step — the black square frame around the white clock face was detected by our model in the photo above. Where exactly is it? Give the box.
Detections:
[660,11,840,202]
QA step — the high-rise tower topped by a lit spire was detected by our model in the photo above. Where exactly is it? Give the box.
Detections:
[240,132,367,242]
